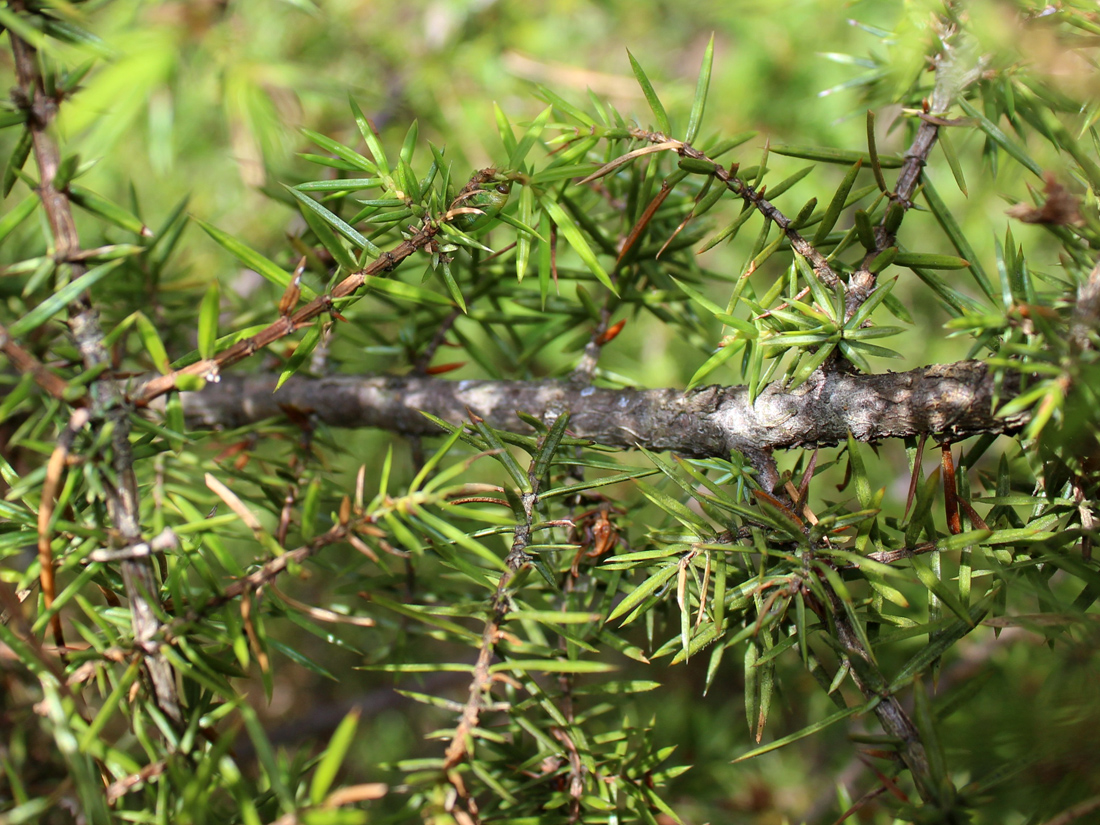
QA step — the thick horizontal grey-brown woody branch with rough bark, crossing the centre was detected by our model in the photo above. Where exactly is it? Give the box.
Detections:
[176,361,1026,458]
